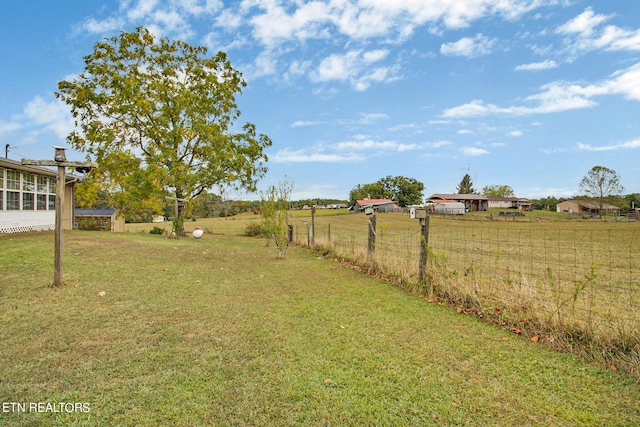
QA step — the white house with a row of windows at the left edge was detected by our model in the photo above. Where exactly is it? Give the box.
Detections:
[0,158,78,233]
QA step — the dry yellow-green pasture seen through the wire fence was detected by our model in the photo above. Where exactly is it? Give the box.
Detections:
[294,214,640,364]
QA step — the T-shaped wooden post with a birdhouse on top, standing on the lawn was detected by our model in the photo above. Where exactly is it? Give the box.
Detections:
[22,146,98,286]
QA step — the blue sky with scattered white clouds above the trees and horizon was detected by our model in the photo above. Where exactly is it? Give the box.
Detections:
[0,0,640,199]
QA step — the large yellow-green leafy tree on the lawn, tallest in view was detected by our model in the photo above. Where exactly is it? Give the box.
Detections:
[56,28,271,235]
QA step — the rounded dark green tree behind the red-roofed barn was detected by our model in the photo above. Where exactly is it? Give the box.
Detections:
[349,176,424,207]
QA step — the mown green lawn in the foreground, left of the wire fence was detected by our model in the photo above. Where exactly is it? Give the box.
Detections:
[0,231,640,426]
